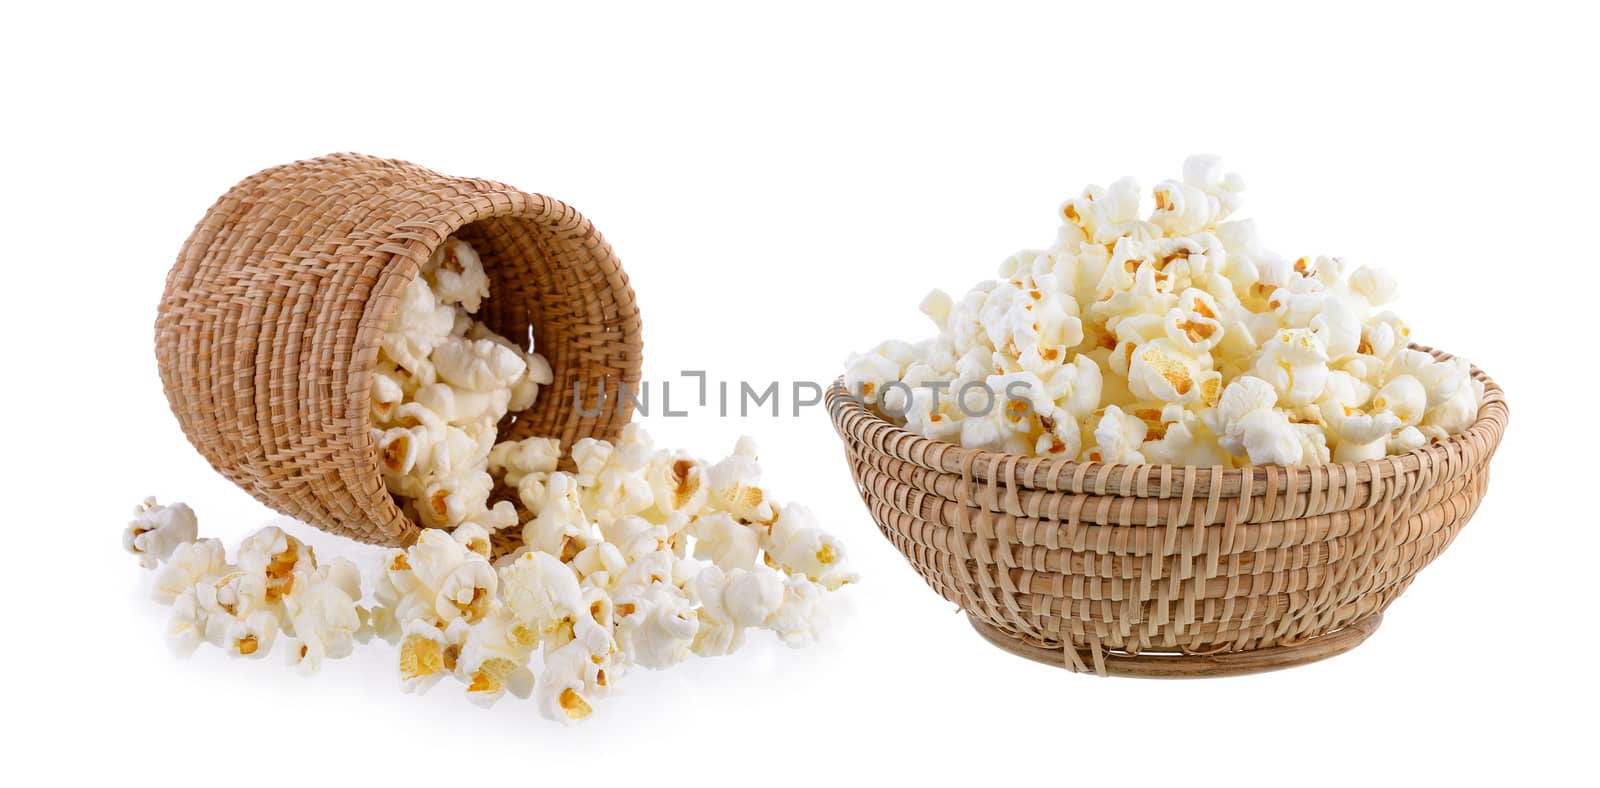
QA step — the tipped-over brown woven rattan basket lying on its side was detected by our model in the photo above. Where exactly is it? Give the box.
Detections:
[155,154,642,545]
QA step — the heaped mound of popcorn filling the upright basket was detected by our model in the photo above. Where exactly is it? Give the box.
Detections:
[845,155,1483,468]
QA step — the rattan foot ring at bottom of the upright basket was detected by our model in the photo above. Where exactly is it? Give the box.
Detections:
[968,613,1384,679]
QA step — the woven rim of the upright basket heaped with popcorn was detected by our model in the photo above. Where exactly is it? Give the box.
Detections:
[826,343,1510,498]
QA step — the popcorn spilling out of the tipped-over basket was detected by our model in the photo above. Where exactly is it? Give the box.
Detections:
[123,239,854,722]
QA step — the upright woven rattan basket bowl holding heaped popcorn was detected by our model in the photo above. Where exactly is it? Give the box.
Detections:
[827,348,1507,677]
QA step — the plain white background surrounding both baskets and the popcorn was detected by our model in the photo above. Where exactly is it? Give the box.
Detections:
[0,2,1600,785]
